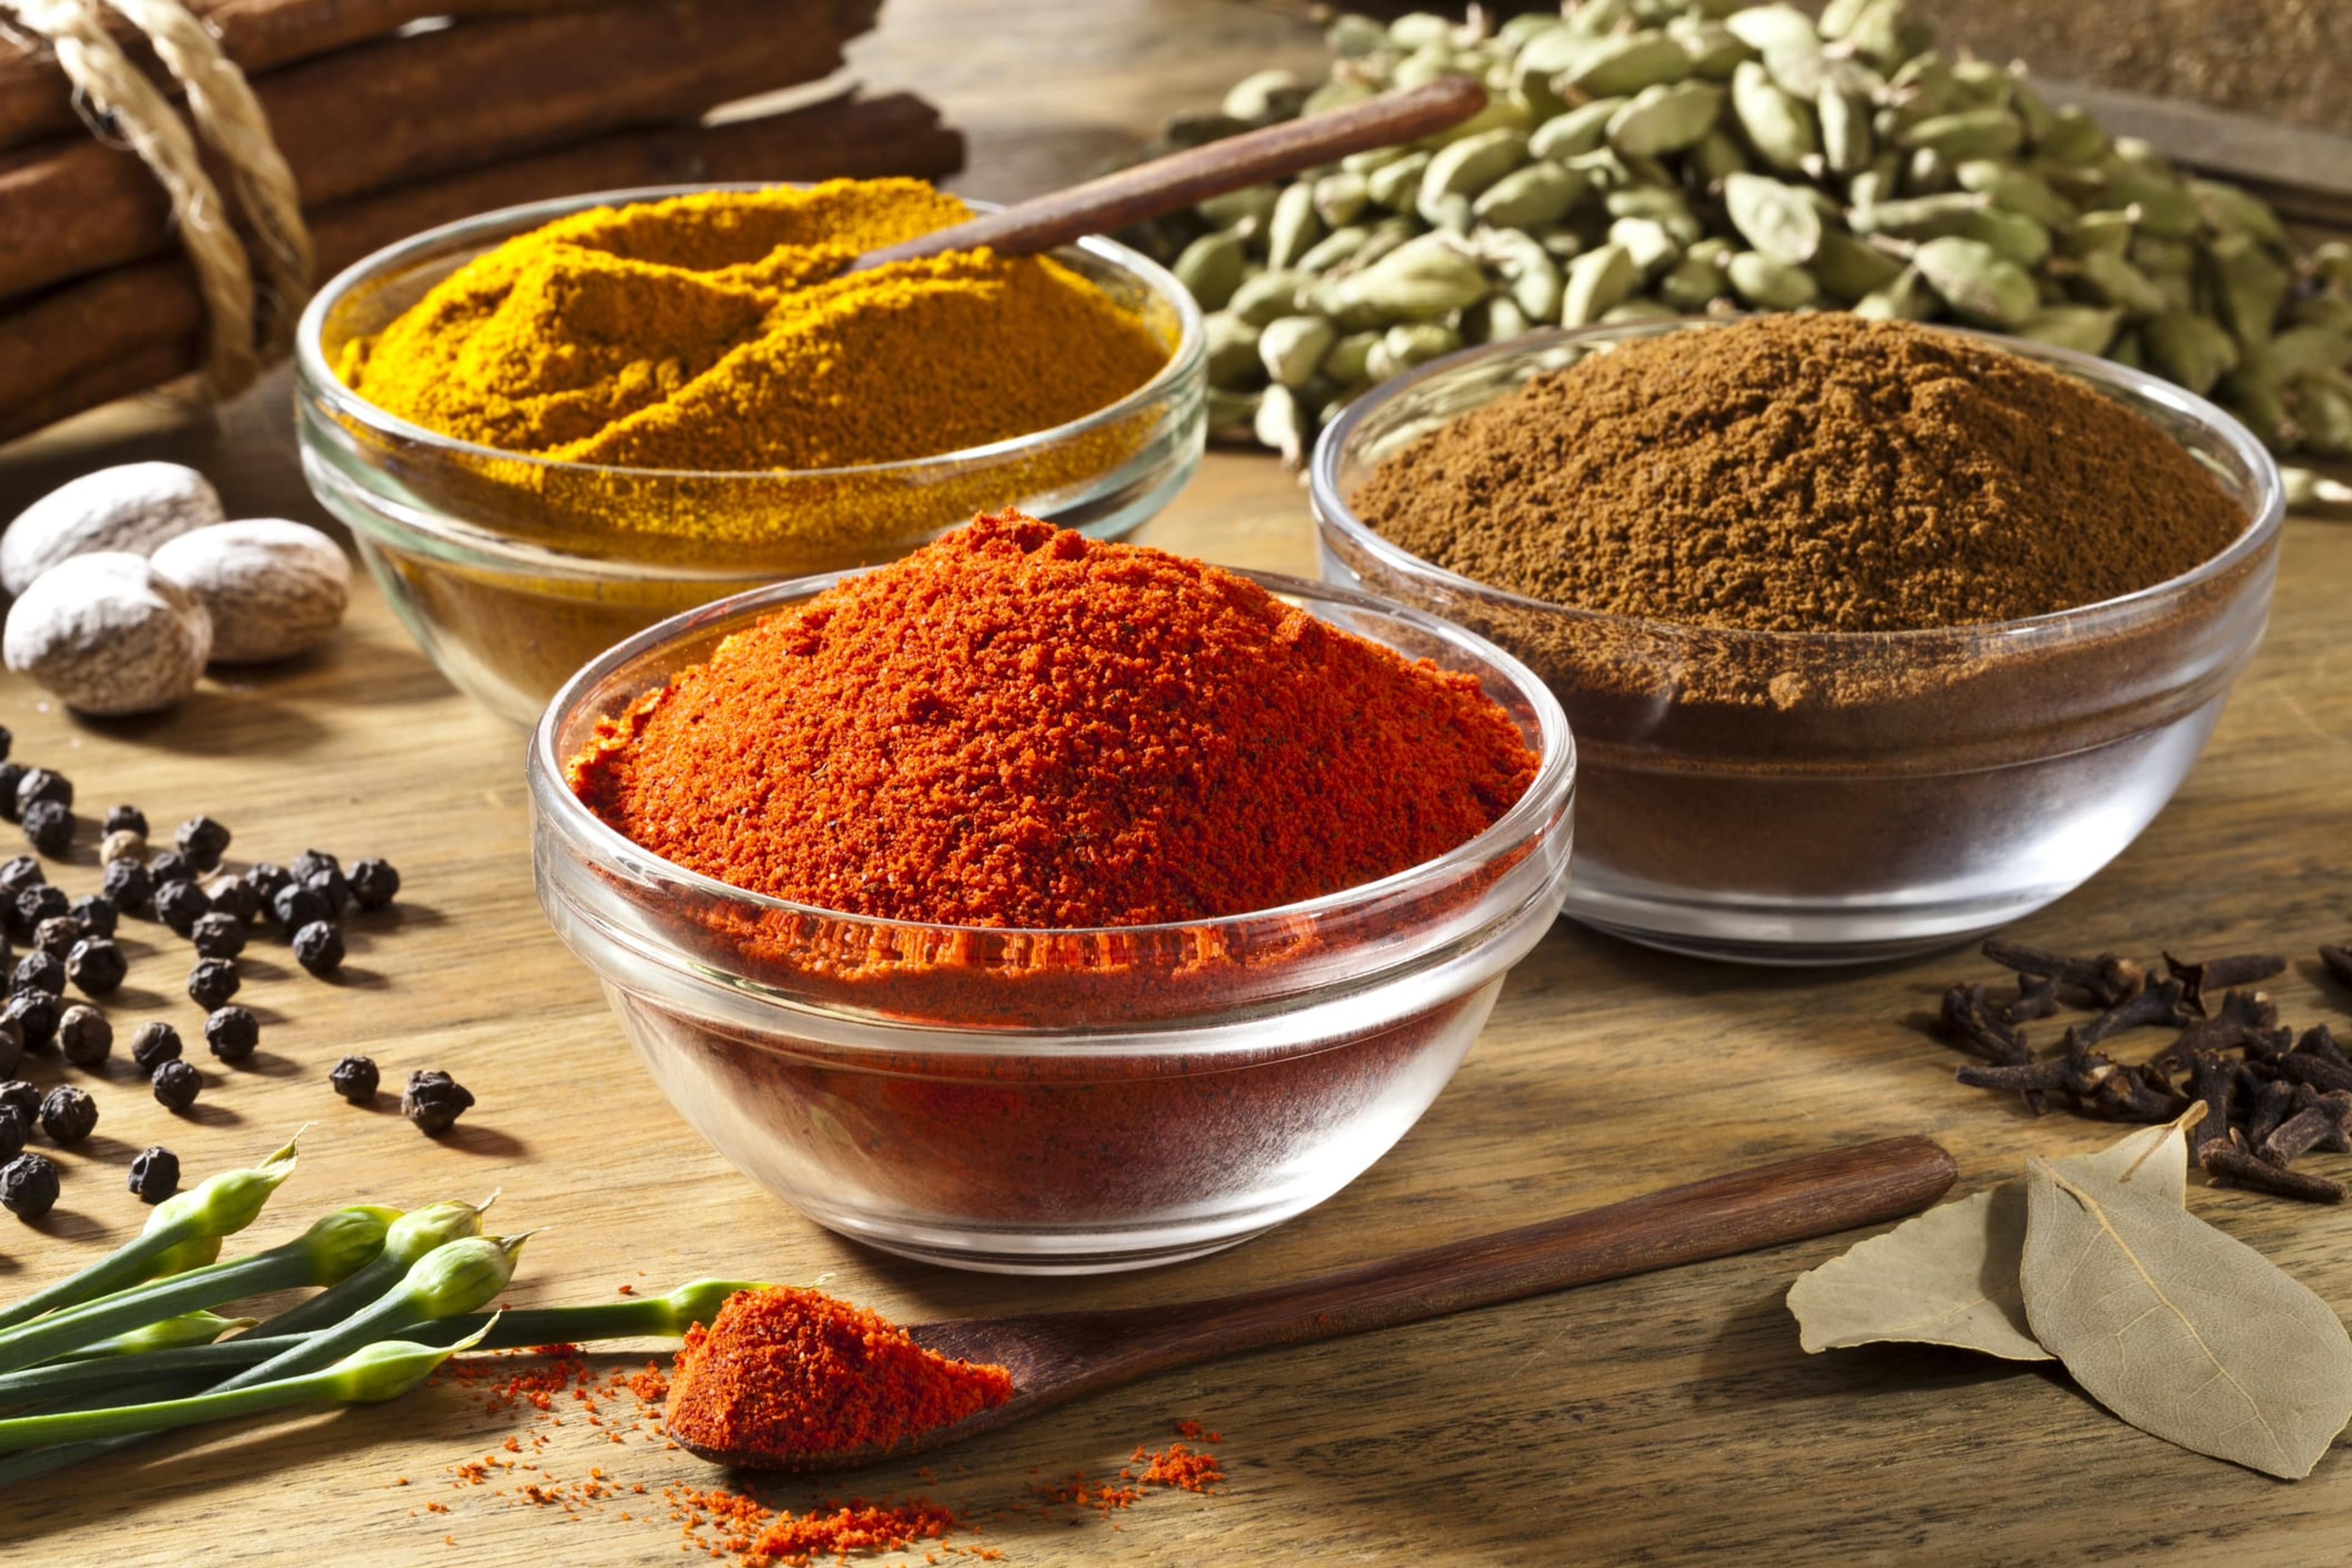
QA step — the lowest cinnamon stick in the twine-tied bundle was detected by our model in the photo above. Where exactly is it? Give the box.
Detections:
[0,94,964,442]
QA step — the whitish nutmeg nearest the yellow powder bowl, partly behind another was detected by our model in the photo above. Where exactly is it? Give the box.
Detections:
[153,517,350,663]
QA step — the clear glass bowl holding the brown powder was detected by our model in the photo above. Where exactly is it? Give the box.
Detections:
[1310,320,2284,964]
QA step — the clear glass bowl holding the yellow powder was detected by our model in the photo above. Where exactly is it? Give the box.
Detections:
[294,186,1207,724]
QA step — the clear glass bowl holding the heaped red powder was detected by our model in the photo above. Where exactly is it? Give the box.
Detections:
[529,573,1576,1274]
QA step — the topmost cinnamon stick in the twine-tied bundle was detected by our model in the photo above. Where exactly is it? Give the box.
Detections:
[0,0,595,151]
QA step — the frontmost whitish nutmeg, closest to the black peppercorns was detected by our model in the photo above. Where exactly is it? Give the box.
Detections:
[0,550,212,715]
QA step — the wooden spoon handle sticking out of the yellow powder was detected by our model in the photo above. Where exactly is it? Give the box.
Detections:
[846,75,1487,273]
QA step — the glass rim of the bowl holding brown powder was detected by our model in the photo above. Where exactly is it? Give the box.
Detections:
[1308,312,2286,651]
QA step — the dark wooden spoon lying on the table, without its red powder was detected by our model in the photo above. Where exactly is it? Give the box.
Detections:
[670,1138,1957,1472]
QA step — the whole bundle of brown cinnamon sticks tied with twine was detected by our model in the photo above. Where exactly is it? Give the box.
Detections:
[0,0,962,442]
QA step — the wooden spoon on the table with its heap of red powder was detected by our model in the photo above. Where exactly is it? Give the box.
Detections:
[668,1138,1957,1472]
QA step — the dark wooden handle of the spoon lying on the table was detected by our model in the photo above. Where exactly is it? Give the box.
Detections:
[1072,1138,1959,1380]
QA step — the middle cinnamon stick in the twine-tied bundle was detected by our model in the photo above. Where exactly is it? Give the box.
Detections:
[0,0,868,298]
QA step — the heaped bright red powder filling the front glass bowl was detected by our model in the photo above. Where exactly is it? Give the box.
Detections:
[569,513,1538,929]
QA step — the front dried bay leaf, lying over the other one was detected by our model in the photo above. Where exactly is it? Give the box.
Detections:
[2022,1147,2352,1481]
